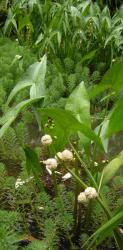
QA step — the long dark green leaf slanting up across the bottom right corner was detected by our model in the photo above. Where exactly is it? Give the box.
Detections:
[87,211,123,249]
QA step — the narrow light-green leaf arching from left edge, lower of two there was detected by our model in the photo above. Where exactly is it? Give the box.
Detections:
[0,96,44,138]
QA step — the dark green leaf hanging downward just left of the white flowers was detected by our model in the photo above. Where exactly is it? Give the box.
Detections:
[24,147,43,191]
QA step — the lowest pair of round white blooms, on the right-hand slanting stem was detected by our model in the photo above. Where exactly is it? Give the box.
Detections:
[78,187,98,203]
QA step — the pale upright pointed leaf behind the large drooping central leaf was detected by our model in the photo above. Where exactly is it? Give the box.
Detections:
[65,82,91,145]
